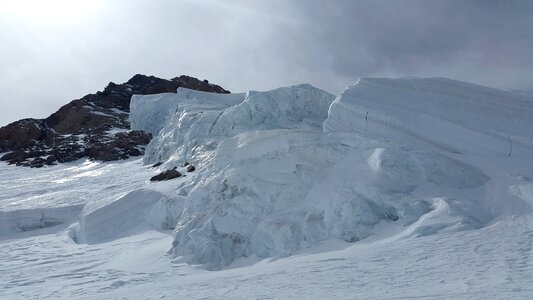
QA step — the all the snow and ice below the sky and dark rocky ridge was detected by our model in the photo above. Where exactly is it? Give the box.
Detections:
[0,79,533,299]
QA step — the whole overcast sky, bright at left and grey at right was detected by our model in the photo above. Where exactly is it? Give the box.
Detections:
[0,0,533,125]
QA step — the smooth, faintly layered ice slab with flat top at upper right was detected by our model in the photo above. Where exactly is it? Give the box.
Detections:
[324,78,533,155]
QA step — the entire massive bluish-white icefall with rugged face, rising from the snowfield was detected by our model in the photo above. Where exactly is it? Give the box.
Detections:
[132,79,531,269]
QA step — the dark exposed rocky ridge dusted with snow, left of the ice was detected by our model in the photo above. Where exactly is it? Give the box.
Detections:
[0,74,229,167]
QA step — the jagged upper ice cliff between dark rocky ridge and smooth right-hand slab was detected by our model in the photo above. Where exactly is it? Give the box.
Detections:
[131,85,334,163]
